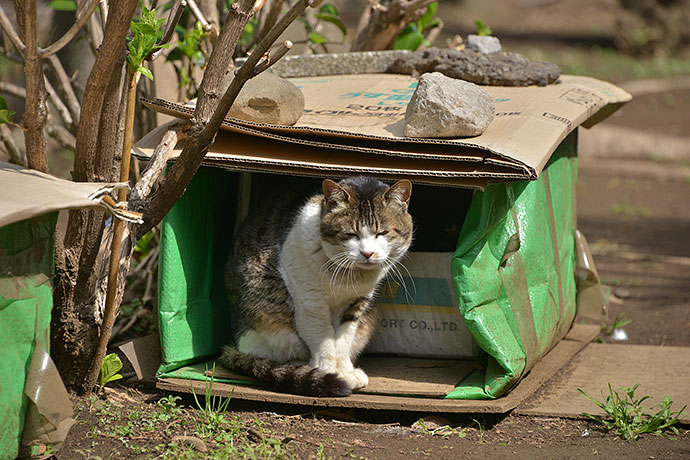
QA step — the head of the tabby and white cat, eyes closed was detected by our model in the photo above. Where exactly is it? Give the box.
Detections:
[321,176,412,269]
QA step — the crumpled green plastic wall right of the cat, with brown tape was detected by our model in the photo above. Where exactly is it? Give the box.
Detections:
[447,133,577,399]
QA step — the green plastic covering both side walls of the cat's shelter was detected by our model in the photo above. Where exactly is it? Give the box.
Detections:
[159,132,577,399]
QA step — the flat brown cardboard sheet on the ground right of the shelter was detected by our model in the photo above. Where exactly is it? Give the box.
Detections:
[515,343,690,417]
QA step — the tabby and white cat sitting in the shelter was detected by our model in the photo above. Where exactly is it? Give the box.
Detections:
[220,176,413,396]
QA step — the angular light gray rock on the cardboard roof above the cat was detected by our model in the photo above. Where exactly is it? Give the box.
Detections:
[404,72,494,138]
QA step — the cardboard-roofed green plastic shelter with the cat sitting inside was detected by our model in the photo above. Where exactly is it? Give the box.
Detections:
[129,60,630,412]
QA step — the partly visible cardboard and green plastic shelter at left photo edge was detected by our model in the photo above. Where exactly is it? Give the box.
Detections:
[0,162,141,459]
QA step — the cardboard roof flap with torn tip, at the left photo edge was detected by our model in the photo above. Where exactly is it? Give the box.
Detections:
[0,162,141,227]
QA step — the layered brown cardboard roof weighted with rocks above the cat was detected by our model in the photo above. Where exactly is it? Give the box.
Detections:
[140,74,631,184]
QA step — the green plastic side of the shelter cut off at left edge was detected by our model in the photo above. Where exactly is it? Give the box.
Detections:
[0,213,57,459]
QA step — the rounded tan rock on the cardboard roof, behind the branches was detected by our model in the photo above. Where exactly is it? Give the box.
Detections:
[224,72,304,126]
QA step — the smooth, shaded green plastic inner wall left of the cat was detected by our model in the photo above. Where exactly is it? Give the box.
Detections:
[158,168,236,375]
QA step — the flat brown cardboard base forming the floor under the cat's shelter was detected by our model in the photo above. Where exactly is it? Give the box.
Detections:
[156,325,599,413]
